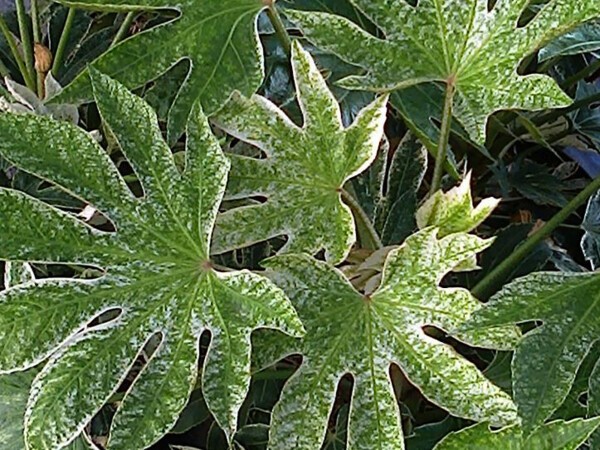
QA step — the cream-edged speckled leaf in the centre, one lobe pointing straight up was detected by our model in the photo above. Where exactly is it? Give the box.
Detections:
[212,42,387,263]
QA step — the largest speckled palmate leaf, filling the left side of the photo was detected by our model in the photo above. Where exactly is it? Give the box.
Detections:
[0,71,302,450]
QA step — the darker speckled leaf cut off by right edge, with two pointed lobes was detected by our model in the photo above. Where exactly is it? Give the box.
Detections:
[463,272,600,433]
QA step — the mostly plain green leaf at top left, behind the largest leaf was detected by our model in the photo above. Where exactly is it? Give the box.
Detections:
[50,0,265,142]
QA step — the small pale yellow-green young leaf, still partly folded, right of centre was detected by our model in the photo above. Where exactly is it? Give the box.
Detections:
[417,173,500,236]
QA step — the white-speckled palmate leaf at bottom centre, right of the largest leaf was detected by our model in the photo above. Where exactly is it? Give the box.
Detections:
[266,228,517,450]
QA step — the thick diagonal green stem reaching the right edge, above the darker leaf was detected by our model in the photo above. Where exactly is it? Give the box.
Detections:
[471,176,600,299]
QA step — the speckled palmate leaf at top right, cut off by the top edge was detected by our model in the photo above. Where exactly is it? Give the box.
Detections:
[286,0,600,143]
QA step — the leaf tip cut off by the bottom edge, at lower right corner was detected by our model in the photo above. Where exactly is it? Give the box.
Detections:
[434,417,600,450]
